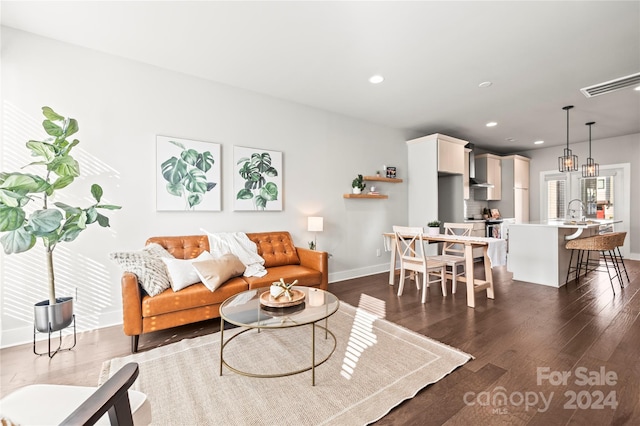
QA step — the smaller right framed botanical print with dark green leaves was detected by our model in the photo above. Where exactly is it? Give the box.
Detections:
[233,146,283,211]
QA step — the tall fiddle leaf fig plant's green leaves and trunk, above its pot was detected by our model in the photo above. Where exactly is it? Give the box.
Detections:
[0,106,120,305]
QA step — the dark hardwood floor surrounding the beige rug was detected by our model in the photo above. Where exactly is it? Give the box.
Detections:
[0,260,640,425]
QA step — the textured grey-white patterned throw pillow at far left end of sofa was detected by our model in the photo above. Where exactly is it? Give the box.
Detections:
[109,244,173,296]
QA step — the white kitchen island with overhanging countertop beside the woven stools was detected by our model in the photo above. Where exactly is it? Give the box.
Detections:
[507,220,619,287]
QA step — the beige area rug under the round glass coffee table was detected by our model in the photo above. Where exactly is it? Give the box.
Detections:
[100,302,472,425]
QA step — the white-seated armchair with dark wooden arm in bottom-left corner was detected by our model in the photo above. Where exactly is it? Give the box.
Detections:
[0,363,151,426]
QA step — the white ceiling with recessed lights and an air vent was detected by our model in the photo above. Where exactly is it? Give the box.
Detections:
[0,1,640,153]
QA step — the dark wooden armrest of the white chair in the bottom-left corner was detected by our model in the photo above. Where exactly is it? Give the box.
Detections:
[60,362,139,426]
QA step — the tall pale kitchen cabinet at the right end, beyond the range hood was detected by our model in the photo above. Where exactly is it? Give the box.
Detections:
[491,155,530,223]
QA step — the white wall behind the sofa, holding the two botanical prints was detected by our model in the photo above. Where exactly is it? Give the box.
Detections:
[0,28,407,347]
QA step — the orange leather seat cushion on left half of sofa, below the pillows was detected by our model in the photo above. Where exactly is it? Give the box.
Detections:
[142,277,249,318]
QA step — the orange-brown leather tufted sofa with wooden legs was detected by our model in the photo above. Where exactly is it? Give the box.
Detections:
[121,231,329,352]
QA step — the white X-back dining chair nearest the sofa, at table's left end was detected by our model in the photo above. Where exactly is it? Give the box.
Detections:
[393,226,447,303]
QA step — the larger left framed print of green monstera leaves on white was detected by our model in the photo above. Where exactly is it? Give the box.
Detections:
[156,136,221,211]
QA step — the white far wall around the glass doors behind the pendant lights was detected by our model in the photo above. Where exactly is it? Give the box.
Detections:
[519,134,640,260]
